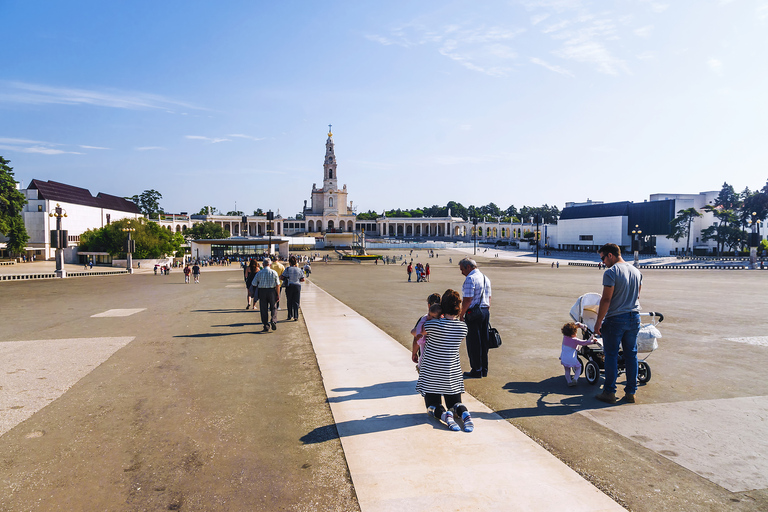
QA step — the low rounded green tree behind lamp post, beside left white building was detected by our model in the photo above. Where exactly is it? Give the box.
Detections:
[79,218,184,259]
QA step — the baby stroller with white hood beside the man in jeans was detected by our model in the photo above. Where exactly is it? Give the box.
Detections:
[571,293,664,385]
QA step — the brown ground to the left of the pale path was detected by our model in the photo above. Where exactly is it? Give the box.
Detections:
[0,268,359,512]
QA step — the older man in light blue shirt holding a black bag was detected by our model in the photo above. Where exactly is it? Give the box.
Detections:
[459,258,491,379]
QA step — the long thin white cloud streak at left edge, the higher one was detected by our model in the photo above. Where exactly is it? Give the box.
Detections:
[0,80,205,110]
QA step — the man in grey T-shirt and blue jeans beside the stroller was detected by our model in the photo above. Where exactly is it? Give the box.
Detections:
[595,244,643,404]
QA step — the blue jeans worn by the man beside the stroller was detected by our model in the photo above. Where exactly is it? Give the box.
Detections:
[600,312,640,395]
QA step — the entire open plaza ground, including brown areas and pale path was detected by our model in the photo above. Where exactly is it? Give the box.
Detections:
[0,250,768,511]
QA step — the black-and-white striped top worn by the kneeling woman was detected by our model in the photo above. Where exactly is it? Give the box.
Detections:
[416,318,467,395]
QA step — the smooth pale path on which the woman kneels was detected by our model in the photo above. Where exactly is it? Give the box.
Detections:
[301,283,624,512]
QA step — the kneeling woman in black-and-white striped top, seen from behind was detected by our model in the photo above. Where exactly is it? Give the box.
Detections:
[416,290,474,432]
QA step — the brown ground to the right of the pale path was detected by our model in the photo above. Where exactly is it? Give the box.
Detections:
[312,250,768,512]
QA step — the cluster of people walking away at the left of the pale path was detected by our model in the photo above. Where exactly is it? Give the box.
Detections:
[243,255,311,332]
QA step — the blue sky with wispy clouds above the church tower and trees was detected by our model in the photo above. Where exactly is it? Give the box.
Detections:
[0,0,768,217]
